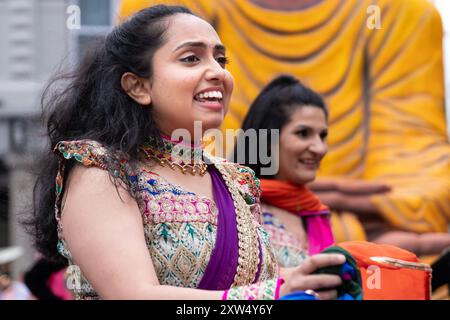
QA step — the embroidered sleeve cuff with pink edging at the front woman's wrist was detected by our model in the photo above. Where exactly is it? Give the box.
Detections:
[222,278,284,300]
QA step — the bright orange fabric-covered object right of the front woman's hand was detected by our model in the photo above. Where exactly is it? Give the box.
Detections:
[339,241,431,300]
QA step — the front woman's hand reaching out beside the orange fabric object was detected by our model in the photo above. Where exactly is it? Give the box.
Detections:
[280,254,345,300]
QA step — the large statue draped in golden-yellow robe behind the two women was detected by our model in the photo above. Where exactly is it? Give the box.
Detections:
[121,0,450,254]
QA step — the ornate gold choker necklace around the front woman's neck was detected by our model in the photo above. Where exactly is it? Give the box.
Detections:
[141,136,208,176]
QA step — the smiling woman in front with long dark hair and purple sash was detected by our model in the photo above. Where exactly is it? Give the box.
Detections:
[26,6,345,300]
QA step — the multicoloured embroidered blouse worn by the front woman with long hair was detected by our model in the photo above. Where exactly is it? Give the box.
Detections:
[55,140,278,299]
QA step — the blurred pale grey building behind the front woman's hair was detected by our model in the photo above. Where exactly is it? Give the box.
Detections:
[0,0,119,275]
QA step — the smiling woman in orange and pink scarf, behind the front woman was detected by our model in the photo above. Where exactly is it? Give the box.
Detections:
[238,75,333,267]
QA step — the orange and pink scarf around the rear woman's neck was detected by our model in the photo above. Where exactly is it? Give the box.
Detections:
[260,179,334,254]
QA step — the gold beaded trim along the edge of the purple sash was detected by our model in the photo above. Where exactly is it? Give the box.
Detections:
[204,152,259,287]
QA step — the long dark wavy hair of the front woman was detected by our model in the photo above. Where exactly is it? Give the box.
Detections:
[24,5,193,262]
